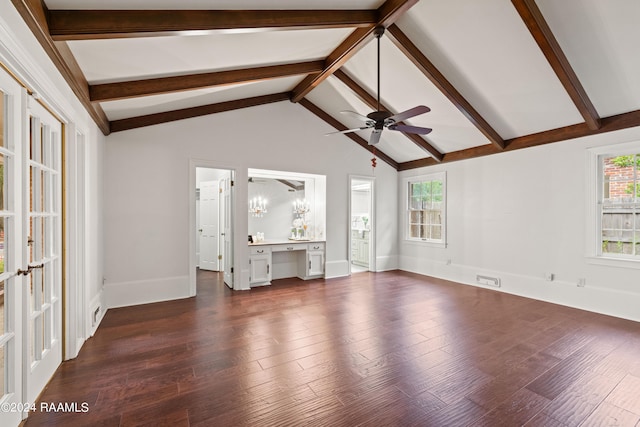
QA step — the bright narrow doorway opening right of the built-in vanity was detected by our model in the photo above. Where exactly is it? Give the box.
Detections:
[349,176,375,274]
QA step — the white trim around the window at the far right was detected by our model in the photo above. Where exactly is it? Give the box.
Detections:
[585,141,640,269]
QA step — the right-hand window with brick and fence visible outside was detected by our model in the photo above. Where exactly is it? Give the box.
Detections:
[596,147,640,261]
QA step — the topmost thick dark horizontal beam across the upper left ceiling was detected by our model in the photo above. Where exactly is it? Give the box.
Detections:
[49,10,377,40]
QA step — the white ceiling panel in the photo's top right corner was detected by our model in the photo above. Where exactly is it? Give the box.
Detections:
[537,0,640,117]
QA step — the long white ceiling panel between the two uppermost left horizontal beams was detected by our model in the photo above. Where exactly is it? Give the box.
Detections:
[68,29,350,84]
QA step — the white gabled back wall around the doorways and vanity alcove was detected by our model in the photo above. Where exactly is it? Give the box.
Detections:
[105,101,397,306]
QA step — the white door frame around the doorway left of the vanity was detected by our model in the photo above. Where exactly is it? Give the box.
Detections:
[187,159,238,297]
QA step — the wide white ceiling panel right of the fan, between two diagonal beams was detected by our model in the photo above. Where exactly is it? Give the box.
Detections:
[398,0,583,139]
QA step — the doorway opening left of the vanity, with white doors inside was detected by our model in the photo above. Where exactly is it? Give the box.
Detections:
[190,163,235,296]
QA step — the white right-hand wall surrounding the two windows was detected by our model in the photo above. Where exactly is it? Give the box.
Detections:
[398,128,640,320]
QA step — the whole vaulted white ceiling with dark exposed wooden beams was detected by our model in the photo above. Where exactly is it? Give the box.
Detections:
[12,0,640,170]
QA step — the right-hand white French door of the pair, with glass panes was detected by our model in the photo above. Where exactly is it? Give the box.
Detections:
[22,99,62,402]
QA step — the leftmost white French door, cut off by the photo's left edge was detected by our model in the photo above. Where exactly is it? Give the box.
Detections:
[0,69,28,426]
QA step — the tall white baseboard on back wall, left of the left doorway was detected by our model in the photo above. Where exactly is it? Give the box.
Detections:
[104,276,189,308]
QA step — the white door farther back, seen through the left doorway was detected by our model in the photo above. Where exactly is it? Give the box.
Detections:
[199,181,221,271]
